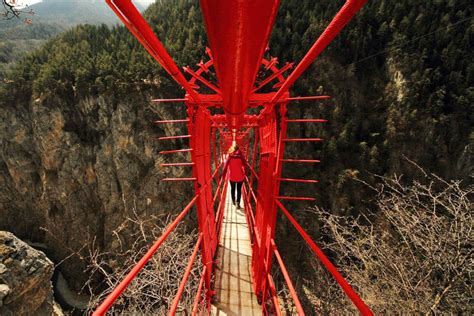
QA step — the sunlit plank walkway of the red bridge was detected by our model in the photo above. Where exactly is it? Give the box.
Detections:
[212,187,262,316]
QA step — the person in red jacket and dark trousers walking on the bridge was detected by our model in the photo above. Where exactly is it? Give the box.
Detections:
[223,145,249,209]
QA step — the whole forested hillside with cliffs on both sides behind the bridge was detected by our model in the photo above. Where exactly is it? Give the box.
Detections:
[0,0,474,312]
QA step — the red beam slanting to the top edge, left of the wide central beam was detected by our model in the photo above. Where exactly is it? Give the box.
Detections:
[106,0,199,102]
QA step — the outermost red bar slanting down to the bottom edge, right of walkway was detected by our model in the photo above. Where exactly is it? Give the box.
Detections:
[276,200,372,315]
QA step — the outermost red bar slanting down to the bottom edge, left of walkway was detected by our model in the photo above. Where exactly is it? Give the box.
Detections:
[92,194,199,316]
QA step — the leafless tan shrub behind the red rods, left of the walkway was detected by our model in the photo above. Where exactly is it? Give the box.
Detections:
[87,210,202,315]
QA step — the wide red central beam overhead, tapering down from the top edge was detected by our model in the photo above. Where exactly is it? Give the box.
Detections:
[200,0,279,128]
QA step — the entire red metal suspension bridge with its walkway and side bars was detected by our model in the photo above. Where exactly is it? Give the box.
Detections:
[94,0,372,315]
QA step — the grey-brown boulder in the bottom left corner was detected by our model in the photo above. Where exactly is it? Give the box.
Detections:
[0,231,54,315]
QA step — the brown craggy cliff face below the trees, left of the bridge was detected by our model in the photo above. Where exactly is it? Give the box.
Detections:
[0,93,193,291]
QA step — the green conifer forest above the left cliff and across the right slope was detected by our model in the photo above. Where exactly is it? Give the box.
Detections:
[0,0,474,207]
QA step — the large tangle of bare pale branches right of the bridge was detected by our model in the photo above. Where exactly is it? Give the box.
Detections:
[306,173,474,314]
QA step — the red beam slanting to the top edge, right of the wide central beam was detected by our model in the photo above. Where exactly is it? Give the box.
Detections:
[272,0,367,102]
